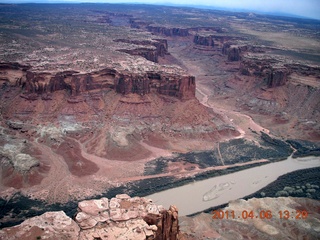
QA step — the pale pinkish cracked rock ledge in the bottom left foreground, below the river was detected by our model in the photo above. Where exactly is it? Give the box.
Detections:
[0,194,179,240]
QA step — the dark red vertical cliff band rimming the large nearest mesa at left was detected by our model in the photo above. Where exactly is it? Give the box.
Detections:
[0,62,195,100]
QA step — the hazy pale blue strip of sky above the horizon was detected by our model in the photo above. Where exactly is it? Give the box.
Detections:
[0,0,320,19]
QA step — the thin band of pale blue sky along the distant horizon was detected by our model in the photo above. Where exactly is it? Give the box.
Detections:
[0,0,320,20]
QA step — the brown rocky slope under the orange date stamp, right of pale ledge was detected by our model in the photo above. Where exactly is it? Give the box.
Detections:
[179,197,320,240]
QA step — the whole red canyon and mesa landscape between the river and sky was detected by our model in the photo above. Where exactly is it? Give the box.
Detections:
[0,4,320,236]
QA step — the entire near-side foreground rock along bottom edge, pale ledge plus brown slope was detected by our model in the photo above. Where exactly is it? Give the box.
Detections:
[0,194,320,240]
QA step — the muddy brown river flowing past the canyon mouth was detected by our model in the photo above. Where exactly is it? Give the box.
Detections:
[146,156,320,216]
